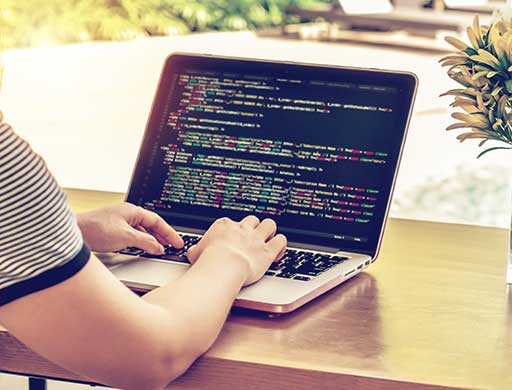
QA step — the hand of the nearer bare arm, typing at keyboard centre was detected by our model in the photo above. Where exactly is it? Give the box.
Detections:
[187,215,287,286]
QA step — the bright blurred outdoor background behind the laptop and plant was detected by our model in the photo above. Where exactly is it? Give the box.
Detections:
[0,0,512,235]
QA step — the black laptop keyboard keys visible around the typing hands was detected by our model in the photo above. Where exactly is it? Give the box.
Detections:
[118,234,348,281]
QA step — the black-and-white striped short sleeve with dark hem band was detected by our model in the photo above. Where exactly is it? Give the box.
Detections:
[0,123,90,305]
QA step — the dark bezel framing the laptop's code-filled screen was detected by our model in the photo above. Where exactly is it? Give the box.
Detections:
[126,53,417,258]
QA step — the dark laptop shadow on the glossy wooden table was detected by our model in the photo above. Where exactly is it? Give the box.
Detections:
[229,272,383,370]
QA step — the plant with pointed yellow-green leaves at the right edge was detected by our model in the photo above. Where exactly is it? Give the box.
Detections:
[440,9,512,284]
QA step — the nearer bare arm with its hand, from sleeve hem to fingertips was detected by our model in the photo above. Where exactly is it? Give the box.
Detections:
[0,210,286,389]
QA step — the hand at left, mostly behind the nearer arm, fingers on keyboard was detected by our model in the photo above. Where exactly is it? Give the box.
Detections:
[77,203,184,255]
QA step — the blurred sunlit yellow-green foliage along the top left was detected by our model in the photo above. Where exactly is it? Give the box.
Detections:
[0,0,329,48]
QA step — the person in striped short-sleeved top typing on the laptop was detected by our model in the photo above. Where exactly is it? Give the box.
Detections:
[0,114,286,390]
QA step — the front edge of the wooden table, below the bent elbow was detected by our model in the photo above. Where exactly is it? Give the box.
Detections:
[0,328,472,390]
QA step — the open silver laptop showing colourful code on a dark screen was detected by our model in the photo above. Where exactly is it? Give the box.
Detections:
[102,54,417,313]
